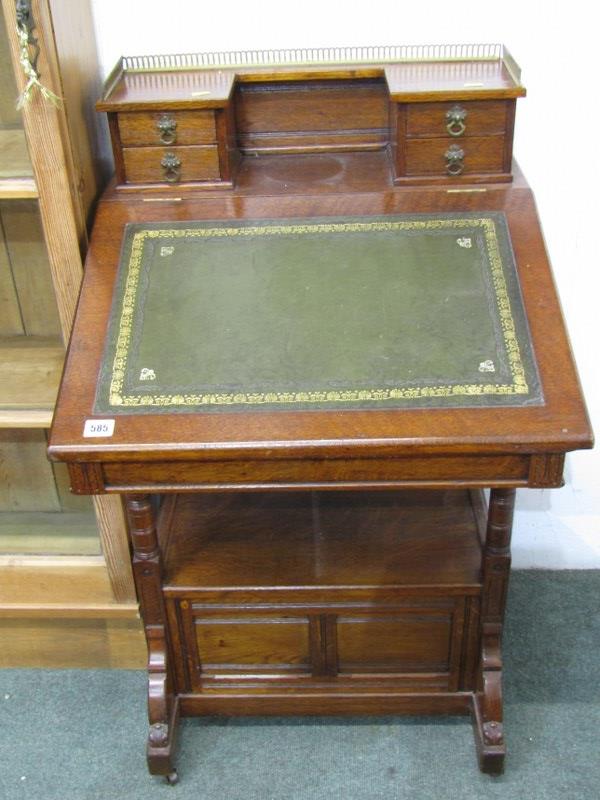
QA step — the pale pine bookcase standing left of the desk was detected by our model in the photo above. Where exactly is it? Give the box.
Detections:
[0,0,143,666]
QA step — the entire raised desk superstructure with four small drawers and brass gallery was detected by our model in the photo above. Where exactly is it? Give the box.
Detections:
[97,45,525,191]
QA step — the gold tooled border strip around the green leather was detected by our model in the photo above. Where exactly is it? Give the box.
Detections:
[109,218,529,407]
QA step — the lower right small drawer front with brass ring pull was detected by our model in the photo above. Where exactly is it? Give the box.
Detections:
[405,136,505,177]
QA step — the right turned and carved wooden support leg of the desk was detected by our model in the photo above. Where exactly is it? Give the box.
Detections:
[472,489,515,774]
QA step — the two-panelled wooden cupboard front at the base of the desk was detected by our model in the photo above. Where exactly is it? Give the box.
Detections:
[176,597,470,693]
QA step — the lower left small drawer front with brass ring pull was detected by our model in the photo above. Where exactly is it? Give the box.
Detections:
[123,145,221,184]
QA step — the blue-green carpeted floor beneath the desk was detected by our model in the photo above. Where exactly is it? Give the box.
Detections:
[0,571,600,800]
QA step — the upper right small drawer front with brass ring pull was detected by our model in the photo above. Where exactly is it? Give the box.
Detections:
[406,100,508,139]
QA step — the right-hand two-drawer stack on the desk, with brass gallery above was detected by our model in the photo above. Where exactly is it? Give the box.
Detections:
[386,53,525,184]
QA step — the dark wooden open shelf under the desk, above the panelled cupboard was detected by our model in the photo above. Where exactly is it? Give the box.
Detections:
[161,491,481,594]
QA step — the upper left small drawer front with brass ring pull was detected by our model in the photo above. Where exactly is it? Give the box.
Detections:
[119,111,217,147]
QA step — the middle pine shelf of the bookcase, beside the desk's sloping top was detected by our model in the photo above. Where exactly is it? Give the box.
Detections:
[0,336,65,428]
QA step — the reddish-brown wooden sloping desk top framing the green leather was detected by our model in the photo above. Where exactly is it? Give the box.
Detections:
[49,153,592,492]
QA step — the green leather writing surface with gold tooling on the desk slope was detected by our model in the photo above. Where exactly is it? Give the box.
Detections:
[95,212,542,414]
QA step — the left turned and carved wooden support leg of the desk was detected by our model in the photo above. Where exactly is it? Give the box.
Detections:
[125,494,178,783]
